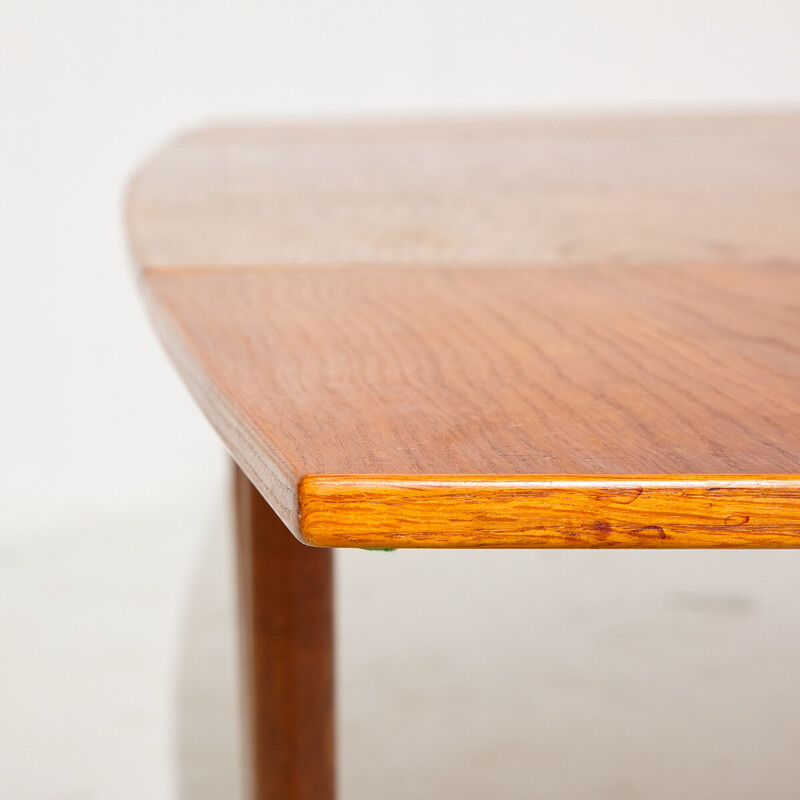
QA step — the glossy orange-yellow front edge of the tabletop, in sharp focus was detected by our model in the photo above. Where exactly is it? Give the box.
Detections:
[298,475,800,548]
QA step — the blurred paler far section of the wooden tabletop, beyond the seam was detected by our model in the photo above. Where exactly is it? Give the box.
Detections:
[128,114,800,267]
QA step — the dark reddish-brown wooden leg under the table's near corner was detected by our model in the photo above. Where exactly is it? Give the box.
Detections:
[235,467,335,800]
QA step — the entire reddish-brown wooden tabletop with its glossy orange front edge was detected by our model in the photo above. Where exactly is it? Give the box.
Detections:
[128,115,800,547]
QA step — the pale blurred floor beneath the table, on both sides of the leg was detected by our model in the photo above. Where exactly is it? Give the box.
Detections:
[0,496,800,800]
